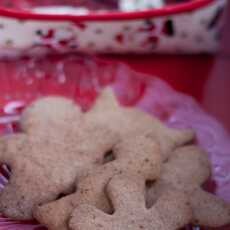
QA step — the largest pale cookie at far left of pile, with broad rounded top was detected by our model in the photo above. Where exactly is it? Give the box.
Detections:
[0,97,117,219]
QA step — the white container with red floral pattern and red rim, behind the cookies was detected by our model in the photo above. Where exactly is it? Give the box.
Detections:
[0,0,227,57]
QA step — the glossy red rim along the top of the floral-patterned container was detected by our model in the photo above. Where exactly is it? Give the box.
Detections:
[0,0,214,21]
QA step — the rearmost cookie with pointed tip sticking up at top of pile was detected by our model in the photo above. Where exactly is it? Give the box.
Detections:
[86,88,194,159]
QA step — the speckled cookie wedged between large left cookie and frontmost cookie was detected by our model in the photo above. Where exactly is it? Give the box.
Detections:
[34,135,161,230]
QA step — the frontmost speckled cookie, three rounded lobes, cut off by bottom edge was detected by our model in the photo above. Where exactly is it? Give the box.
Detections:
[69,175,192,230]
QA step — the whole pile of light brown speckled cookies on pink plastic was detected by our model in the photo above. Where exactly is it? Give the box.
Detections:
[0,89,230,230]
